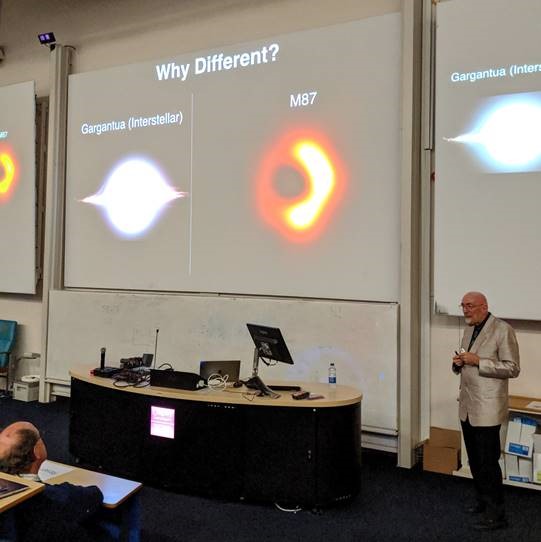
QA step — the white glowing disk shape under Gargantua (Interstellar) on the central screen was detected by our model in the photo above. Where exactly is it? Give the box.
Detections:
[82,158,186,237]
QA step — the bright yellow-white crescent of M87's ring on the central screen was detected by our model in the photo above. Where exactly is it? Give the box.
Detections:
[285,141,335,230]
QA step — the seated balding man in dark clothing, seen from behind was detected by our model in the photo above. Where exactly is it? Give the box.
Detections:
[0,422,112,541]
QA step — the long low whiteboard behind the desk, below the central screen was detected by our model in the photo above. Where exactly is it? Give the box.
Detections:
[46,290,398,432]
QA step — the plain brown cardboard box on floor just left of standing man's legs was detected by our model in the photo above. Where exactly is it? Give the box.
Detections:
[423,427,460,474]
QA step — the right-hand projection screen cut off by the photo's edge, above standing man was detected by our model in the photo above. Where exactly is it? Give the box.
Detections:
[434,0,541,319]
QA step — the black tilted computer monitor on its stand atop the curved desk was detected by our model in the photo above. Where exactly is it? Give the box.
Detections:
[245,324,293,398]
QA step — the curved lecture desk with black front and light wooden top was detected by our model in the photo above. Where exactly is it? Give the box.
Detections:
[70,367,361,507]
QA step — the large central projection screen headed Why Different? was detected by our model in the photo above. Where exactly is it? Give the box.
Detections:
[65,14,401,301]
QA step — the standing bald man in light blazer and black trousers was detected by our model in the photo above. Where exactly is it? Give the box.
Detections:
[453,292,520,530]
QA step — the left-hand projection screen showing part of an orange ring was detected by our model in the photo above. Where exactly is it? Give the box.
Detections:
[0,81,36,294]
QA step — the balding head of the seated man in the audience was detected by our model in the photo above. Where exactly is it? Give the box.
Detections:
[0,422,47,474]
